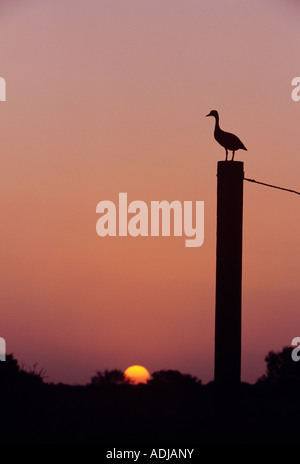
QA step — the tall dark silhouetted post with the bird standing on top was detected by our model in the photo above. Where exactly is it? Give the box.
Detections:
[215,161,244,387]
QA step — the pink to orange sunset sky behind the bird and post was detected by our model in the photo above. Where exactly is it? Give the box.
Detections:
[0,0,300,383]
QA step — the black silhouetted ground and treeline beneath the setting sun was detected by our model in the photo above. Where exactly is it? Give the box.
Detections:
[0,349,300,446]
